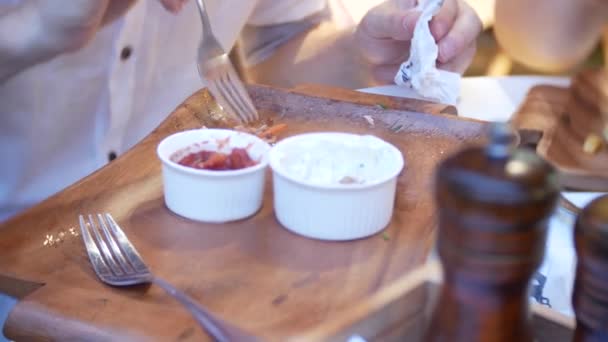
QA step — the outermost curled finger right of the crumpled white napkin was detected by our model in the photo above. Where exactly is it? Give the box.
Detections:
[438,1,482,63]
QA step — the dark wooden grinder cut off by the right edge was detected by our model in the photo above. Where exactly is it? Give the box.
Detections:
[572,196,608,342]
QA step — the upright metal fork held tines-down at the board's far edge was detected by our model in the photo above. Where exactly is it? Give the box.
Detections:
[196,0,259,123]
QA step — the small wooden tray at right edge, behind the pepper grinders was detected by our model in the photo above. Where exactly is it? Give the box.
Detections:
[513,70,608,192]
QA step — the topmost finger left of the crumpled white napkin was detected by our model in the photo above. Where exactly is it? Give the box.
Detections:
[358,2,420,40]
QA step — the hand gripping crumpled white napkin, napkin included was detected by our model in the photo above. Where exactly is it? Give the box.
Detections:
[356,0,482,104]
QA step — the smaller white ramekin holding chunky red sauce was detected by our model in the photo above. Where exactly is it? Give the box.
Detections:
[157,129,270,223]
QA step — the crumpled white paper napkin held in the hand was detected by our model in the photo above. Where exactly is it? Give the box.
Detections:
[395,0,461,105]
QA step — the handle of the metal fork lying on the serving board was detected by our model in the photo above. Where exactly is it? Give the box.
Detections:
[152,277,230,342]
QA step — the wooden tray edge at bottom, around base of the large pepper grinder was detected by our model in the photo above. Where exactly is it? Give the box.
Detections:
[289,261,575,342]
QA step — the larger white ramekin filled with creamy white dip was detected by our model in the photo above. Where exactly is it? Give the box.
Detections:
[269,133,404,240]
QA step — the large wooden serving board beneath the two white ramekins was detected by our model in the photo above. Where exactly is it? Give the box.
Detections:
[0,86,485,341]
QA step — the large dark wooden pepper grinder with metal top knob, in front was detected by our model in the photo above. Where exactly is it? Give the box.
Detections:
[426,124,559,342]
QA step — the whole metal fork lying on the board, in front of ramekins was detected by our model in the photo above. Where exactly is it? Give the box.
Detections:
[79,213,257,342]
